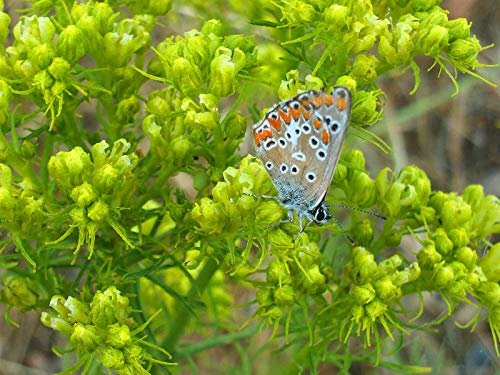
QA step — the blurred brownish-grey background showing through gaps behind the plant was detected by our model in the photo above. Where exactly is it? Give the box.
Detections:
[0,0,500,375]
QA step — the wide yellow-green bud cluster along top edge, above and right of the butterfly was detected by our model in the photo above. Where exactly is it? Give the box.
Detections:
[270,0,492,94]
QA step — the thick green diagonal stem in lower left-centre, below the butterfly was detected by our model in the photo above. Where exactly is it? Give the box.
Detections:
[161,254,220,355]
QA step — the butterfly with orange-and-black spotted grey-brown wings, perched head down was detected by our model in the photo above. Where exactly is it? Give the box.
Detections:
[253,86,352,238]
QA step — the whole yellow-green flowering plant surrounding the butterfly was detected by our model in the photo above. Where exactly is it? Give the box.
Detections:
[0,0,500,374]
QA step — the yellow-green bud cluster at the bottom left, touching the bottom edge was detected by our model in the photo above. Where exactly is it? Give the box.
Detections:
[41,287,170,375]
